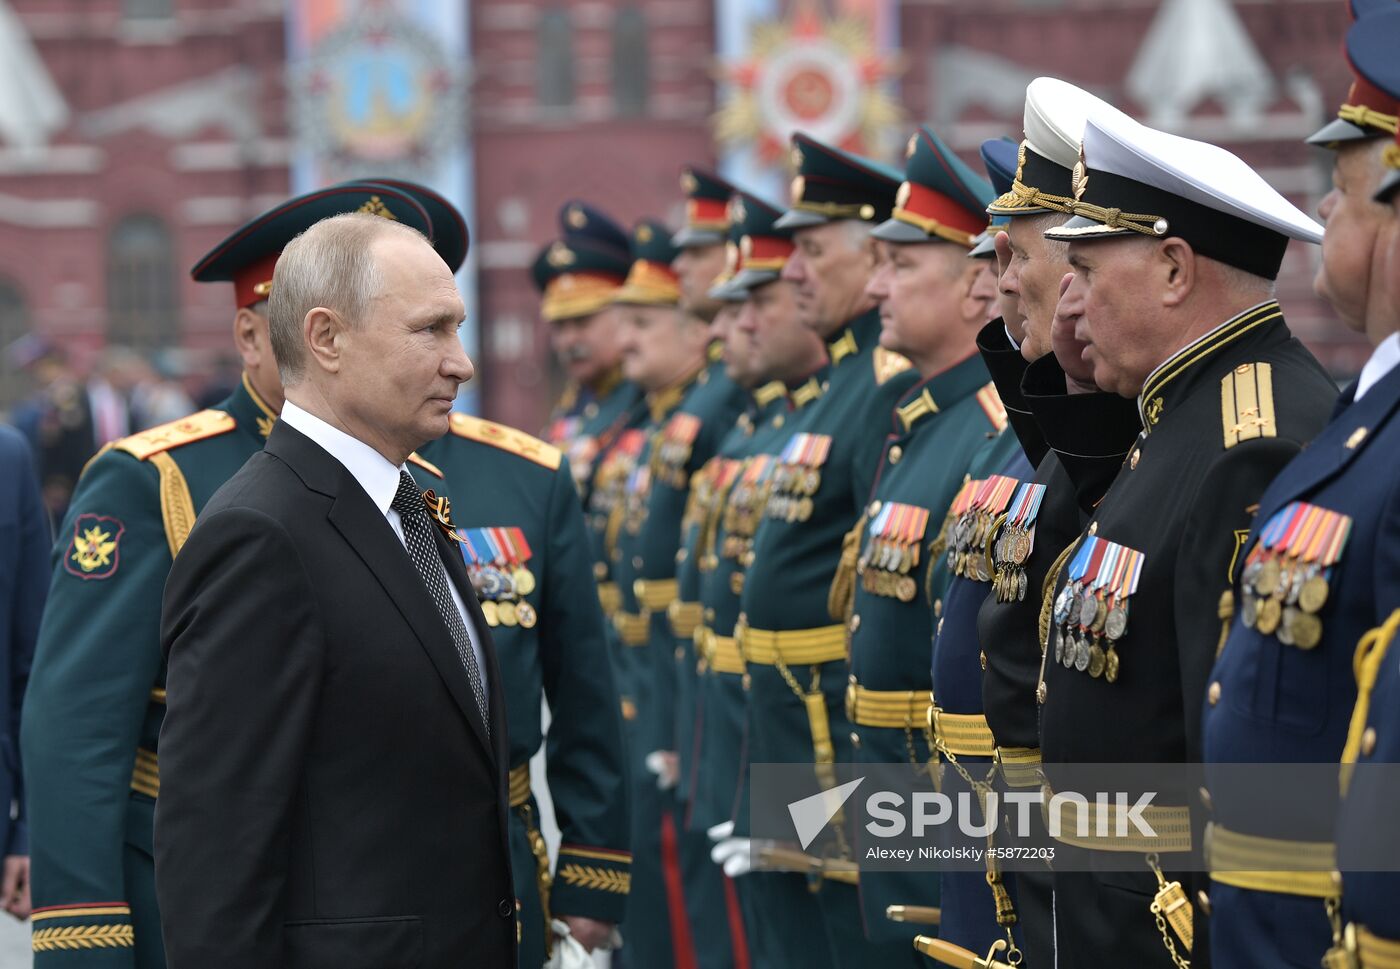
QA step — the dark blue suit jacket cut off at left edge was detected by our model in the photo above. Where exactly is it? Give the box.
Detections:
[0,426,50,854]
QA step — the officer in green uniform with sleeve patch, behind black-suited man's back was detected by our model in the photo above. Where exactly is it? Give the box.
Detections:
[21,183,431,969]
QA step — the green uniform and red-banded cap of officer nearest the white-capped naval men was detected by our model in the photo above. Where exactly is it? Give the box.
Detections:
[833,127,1007,965]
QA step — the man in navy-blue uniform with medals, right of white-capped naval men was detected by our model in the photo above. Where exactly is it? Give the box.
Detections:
[1203,4,1400,966]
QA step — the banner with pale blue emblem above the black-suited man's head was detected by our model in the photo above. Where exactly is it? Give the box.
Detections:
[286,0,479,412]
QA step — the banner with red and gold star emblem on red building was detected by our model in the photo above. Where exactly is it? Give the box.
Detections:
[715,0,903,199]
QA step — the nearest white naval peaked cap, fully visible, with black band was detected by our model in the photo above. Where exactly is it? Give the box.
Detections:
[1046,115,1322,279]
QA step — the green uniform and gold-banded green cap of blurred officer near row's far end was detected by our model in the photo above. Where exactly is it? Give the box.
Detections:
[612,221,743,966]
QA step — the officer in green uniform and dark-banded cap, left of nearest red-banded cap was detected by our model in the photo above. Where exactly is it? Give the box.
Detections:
[735,133,914,966]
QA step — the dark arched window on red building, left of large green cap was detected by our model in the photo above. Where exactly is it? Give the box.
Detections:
[106,214,179,350]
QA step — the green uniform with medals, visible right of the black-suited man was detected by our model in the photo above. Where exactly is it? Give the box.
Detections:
[419,414,631,968]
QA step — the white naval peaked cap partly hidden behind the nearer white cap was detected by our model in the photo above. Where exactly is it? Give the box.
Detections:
[987,77,1128,216]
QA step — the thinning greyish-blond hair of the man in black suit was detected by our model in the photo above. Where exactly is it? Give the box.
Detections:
[267,211,427,385]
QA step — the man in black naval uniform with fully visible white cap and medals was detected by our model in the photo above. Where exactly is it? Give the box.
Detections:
[1040,115,1336,966]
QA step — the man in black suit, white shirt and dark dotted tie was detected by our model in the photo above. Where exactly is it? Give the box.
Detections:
[155,213,515,969]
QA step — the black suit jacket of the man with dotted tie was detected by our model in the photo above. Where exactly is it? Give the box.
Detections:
[155,423,515,969]
